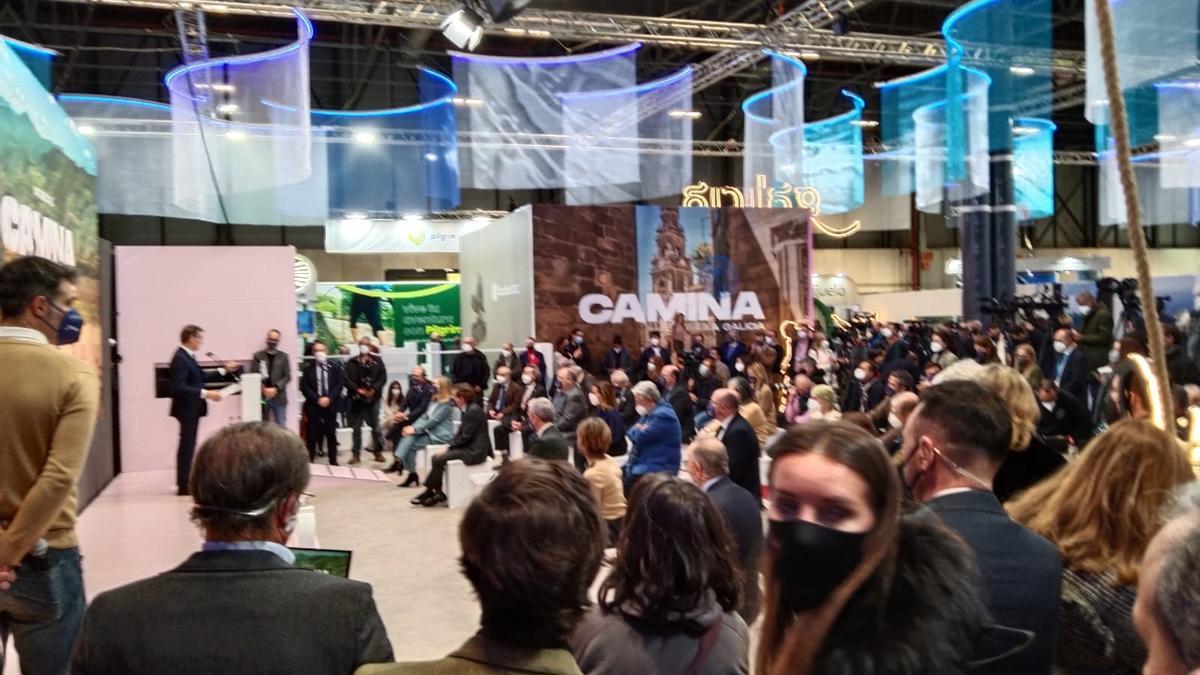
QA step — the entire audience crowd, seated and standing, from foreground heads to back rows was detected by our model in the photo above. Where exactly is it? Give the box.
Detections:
[0,253,1200,675]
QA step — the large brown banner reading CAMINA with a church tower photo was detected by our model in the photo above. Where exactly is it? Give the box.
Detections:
[533,205,814,353]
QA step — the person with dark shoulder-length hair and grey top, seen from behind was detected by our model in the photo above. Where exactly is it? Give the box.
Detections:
[571,476,750,675]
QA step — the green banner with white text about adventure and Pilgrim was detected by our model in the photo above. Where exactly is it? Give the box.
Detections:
[314,281,462,353]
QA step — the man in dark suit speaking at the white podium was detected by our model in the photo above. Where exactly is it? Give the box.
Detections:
[170,325,238,496]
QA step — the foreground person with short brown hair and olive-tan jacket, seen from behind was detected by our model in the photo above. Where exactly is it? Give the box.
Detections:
[355,460,605,675]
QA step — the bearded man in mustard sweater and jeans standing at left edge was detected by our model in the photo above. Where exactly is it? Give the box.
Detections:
[0,257,100,674]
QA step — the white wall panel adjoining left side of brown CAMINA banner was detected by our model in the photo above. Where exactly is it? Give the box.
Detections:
[458,207,534,350]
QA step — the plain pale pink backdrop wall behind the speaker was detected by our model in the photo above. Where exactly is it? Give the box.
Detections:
[116,246,300,472]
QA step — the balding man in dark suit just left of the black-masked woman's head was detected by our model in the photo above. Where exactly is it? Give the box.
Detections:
[688,437,763,626]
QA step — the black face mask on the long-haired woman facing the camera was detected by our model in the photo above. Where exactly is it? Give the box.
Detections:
[768,520,866,611]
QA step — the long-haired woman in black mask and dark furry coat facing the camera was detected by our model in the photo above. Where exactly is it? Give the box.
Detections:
[756,422,988,675]
